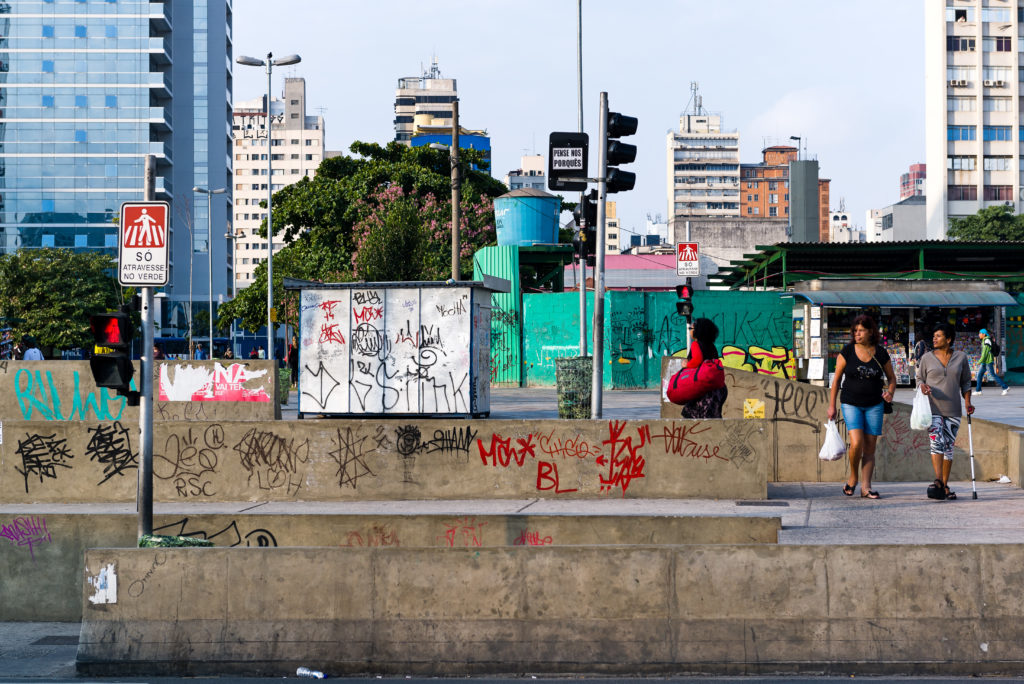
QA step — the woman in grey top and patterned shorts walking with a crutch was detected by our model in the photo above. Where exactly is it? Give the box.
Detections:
[918,323,974,499]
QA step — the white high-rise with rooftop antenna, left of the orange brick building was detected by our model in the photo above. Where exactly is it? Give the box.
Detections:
[666,83,740,233]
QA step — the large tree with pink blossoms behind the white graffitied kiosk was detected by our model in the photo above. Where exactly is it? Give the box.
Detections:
[216,141,516,331]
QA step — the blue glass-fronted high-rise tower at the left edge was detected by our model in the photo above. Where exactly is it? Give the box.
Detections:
[0,0,232,334]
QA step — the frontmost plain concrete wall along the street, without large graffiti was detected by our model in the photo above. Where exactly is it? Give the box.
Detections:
[78,545,1024,676]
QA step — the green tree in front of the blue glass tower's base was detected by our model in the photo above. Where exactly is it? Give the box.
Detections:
[0,248,120,349]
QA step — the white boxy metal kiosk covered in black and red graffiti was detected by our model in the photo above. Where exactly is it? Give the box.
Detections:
[299,288,490,414]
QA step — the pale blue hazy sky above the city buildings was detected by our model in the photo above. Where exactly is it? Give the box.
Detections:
[233,0,925,241]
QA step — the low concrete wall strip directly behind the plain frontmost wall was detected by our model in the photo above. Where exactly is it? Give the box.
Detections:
[0,509,781,622]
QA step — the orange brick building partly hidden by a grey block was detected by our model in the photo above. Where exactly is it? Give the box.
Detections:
[739,145,830,243]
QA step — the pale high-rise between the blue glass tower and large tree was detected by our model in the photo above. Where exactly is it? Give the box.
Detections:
[231,78,325,289]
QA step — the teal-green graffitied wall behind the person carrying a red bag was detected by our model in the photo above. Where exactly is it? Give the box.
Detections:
[522,291,793,389]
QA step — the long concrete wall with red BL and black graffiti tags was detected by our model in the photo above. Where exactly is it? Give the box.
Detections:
[0,420,770,504]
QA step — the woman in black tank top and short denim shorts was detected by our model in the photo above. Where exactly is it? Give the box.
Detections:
[828,313,896,499]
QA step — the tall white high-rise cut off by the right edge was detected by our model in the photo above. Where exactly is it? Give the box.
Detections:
[925,0,1024,240]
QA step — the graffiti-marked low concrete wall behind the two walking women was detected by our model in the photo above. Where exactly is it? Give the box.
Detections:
[662,366,1007,482]
